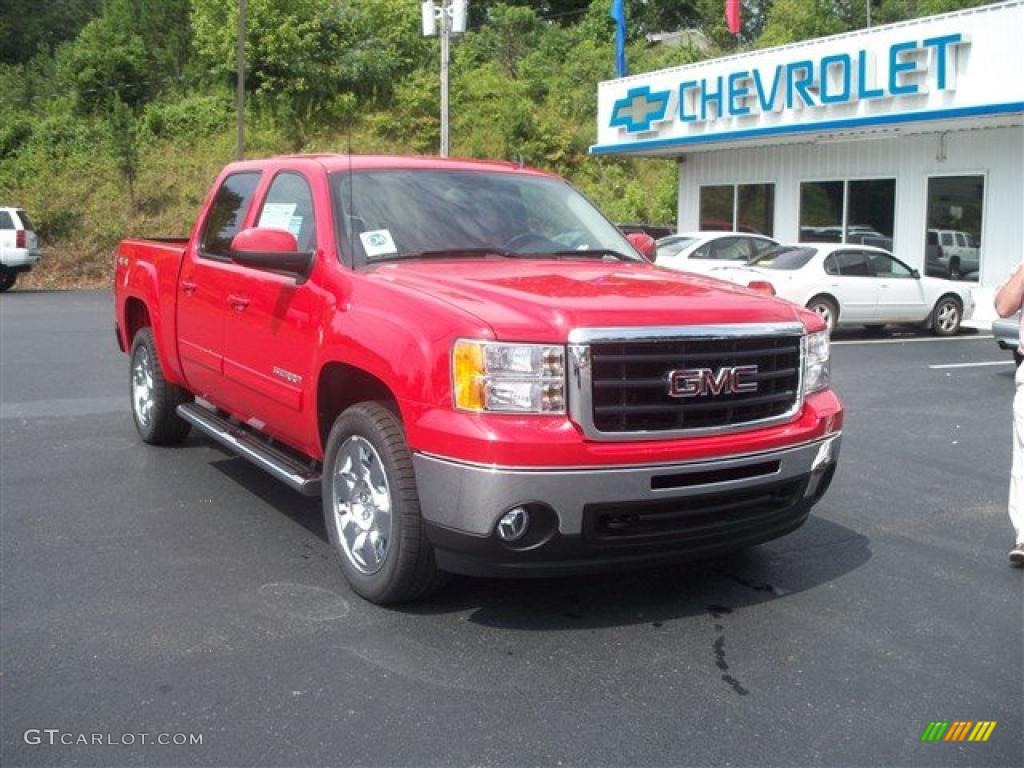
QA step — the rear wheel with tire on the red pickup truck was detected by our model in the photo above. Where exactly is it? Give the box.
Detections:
[128,328,193,445]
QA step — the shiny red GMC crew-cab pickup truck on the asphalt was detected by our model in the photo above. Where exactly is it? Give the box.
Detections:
[115,155,843,603]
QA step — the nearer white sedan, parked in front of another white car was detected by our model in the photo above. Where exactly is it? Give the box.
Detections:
[711,243,974,336]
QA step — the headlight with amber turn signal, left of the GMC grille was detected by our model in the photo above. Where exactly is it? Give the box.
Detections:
[452,339,565,414]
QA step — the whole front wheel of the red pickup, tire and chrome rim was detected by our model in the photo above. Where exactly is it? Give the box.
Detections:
[322,401,443,604]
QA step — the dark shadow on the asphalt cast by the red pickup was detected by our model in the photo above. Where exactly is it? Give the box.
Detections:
[212,450,871,631]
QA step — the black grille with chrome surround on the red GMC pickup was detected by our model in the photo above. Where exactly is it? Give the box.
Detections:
[569,324,803,440]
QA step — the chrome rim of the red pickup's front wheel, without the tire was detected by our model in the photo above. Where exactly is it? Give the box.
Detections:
[331,435,391,574]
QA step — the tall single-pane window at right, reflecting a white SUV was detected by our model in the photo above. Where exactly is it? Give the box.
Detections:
[925,175,985,282]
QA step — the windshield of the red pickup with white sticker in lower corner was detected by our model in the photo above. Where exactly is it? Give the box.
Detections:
[330,170,643,266]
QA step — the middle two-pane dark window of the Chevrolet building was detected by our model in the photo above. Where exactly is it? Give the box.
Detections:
[800,178,896,251]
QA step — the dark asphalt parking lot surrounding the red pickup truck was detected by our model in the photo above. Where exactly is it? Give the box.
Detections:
[0,291,1024,766]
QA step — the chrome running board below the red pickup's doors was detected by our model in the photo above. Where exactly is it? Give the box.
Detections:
[177,402,321,496]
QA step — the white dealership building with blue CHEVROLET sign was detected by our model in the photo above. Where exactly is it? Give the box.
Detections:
[591,0,1024,318]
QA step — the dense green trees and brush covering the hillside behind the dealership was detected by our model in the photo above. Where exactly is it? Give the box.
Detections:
[0,0,981,285]
